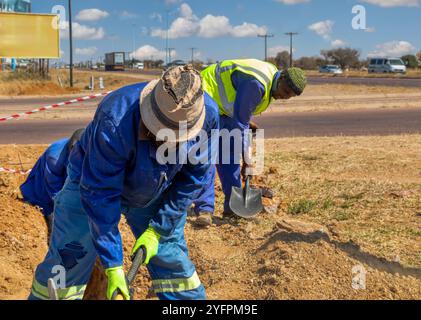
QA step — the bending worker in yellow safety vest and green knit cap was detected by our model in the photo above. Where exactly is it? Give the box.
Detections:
[193,59,307,227]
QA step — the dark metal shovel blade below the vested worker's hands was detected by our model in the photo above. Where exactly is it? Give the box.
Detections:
[229,176,263,219]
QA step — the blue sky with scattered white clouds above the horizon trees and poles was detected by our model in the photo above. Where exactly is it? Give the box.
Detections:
[32,0,421,61]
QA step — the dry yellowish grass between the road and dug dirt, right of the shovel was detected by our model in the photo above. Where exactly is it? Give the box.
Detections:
[249,135,421,267]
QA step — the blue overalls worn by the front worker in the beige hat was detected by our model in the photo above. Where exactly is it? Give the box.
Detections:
[29,83,219,299]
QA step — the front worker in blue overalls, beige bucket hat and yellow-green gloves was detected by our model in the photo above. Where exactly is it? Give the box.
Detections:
[29,66,219,300]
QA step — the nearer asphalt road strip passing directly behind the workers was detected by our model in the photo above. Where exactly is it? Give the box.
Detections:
[0,108,421,144]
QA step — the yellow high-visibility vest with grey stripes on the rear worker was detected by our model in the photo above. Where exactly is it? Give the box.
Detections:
[202,59,278,117]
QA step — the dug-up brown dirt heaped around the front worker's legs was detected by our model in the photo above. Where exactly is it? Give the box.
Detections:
[0,146,421,299]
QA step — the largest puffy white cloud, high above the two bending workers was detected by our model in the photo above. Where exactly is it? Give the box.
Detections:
[151,3,267,39]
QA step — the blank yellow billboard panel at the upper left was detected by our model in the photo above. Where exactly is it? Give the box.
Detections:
[0,12,60,59]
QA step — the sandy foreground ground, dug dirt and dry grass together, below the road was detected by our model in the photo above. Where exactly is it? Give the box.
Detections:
[0,135,421,299]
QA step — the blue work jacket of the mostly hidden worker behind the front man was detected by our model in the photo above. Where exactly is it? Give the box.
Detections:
[20,139,69,216]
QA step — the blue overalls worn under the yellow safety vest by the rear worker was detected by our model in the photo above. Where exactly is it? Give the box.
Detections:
[194,71,281,214]
